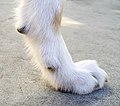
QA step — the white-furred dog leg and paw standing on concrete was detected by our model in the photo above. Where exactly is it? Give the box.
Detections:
[16,0,108,94]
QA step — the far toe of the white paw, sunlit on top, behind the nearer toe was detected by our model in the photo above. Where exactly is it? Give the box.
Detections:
[75,60,108,89]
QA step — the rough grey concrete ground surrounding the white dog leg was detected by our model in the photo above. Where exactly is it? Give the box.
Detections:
[0,0,120,106]
